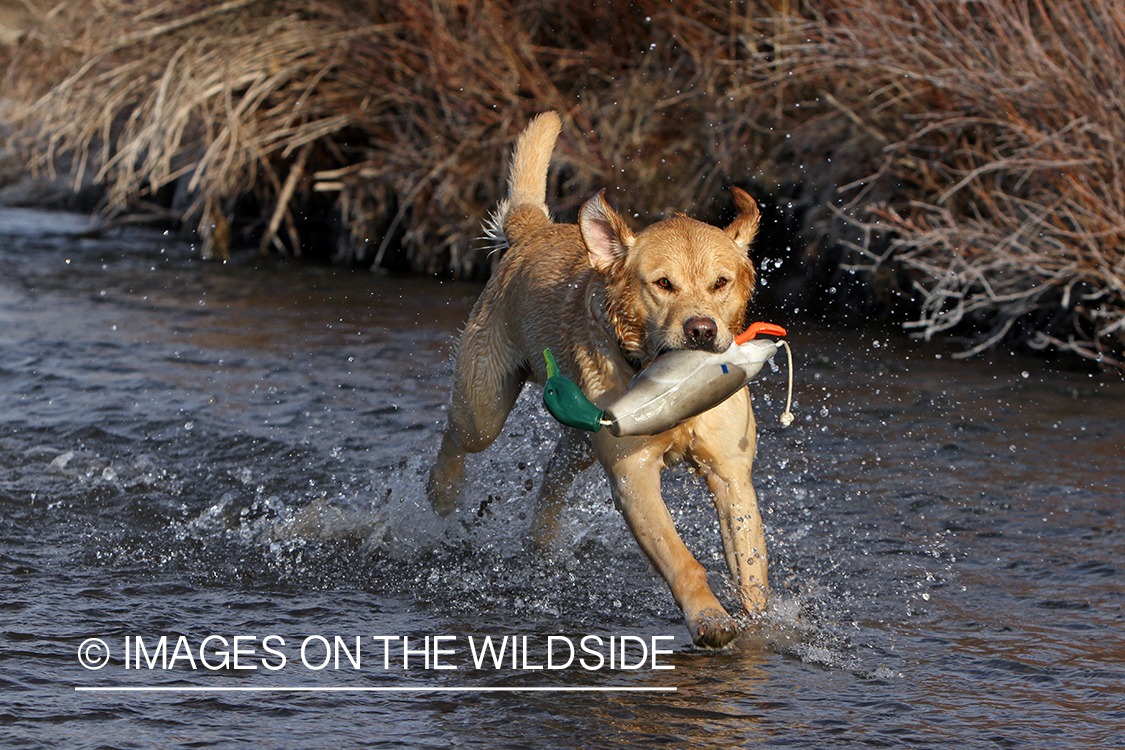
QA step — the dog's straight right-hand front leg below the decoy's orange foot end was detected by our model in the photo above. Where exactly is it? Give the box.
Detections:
[691,390,770,613]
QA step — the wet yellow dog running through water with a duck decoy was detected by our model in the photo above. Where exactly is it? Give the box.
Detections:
[429,112,768,648]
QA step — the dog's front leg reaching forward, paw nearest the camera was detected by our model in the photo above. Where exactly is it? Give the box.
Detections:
[594,434,738,649]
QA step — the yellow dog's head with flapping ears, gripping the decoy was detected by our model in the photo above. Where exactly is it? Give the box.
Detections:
[578,188,759,361]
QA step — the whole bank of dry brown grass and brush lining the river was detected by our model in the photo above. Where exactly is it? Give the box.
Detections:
[5,0,1125,362]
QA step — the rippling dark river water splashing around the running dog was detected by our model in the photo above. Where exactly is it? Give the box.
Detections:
[0,210,1125,748]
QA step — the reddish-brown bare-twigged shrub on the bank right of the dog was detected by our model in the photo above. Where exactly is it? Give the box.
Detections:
[751,0,1125,364]
